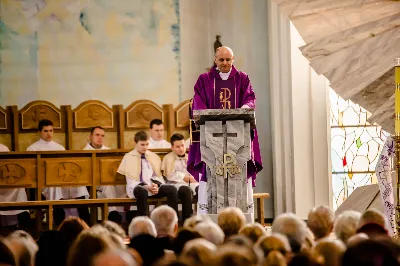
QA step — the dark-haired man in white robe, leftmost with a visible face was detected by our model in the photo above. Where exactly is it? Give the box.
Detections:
[27,119,90,224]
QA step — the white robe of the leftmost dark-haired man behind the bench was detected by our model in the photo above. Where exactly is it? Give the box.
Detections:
[26,139,89,200]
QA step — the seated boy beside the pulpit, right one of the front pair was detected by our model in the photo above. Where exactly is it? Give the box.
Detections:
[161,134,195,220]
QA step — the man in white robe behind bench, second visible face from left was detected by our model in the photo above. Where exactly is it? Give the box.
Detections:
[83,126,128,223]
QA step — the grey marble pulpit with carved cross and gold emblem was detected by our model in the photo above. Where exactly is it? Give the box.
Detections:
[194,109,255,222]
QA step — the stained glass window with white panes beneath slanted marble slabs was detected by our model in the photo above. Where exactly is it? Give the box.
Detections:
[329,89,389,209]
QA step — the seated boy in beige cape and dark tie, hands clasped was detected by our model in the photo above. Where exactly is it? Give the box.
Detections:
[118,131,190,222]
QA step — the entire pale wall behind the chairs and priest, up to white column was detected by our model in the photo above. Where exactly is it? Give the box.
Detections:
[0,0,274,217]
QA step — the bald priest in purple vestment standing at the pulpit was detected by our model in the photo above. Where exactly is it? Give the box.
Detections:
[187,46,263,214]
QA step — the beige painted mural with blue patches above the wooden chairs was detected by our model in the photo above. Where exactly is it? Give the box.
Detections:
[0,0,181,107]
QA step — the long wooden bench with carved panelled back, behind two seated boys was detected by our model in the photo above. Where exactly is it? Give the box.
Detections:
[0,149,269,229]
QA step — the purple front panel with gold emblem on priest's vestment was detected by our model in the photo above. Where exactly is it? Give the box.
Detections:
[213,77,239,109]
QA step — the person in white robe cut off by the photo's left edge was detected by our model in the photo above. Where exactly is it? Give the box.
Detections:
[0,144,30,228]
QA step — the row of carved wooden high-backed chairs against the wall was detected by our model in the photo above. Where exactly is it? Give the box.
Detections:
[0,100,190,151]
